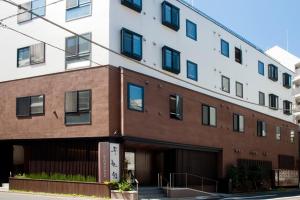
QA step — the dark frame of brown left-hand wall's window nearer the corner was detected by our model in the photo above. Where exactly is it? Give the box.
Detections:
[64,89,92,126]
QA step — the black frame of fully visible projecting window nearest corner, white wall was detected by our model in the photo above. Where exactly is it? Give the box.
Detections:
[121,28,143,61]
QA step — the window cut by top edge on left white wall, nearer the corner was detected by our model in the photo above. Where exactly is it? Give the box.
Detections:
[66,0,92,21]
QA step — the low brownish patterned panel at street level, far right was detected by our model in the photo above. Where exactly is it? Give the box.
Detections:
[274,169,299,186]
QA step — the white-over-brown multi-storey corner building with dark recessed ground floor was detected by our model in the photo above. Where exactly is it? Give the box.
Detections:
[0,0,298,190]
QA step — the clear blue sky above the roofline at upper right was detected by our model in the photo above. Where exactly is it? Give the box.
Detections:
[186,0,300,57]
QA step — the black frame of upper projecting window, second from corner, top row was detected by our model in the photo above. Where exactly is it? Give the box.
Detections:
[161,1,180,31]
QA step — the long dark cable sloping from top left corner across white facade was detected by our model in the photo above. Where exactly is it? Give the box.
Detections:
[2,0,296,115]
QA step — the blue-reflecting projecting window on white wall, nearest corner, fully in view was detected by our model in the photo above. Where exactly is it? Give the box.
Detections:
[121,28,143,61]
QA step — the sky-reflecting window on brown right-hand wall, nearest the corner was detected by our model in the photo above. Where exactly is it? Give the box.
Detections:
[127,83,144,112]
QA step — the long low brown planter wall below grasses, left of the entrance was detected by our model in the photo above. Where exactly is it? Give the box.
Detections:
[9,178,110,198]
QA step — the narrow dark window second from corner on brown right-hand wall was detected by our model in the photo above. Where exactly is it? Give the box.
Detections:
[169,95,183,120]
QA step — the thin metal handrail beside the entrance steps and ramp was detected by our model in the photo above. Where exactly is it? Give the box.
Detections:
[169,173,218,192]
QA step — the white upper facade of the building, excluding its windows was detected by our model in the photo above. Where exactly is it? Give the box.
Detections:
[0,0,294,122]
